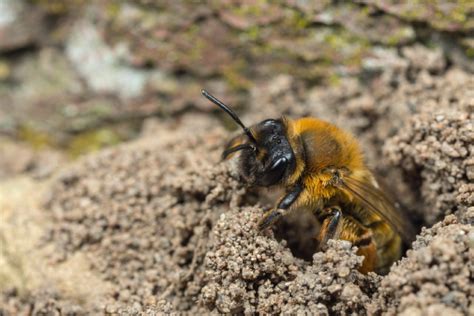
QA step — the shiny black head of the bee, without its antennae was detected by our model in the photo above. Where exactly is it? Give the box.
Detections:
[240,119,296,186]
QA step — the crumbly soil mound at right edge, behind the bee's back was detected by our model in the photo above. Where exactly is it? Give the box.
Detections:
[385,70,474,224]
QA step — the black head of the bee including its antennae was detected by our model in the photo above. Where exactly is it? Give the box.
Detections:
[202,90,296,186]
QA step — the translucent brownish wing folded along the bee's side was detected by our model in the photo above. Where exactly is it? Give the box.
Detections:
[341,176,416,244]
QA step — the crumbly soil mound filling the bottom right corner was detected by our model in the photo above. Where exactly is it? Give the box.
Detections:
[372,214,474,315]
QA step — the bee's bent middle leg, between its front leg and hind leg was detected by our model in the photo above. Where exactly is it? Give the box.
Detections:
[316,206,342,249]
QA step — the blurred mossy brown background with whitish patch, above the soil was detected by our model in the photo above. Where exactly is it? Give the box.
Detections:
[0,0,474,173]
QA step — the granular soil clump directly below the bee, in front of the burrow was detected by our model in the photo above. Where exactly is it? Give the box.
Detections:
[201,208,377,314]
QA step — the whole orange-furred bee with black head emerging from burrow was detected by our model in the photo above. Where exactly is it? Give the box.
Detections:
[202,90,415,274]
